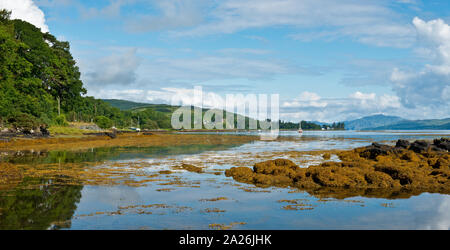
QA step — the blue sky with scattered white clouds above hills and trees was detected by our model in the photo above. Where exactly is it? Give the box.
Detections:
[0,0,450,122]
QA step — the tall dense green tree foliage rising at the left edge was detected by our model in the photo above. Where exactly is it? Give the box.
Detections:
[0,10,86,128]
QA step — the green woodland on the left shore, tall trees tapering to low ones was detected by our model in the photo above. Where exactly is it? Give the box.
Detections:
[0,10,170,130]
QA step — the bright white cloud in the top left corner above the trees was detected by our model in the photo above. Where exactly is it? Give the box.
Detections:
[0,0,49,33]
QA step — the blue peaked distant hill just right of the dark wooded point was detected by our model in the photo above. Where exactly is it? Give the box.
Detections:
[344,115,407,130]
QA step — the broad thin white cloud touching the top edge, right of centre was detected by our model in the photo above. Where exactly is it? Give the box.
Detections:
[173,0,414,47]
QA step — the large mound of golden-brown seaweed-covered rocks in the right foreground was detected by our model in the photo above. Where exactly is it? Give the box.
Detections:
[225,138,450,198]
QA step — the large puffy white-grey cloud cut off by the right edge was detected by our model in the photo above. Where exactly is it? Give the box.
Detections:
[391,17,450,110]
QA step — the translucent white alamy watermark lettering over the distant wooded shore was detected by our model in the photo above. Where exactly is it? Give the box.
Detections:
[171,86,280,140]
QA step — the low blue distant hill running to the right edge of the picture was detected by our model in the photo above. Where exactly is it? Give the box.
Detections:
[371,118,450,130]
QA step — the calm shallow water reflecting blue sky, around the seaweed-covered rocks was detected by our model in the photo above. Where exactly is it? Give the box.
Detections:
[0,131,450,229]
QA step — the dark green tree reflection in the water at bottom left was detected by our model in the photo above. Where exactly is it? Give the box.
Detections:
[0,178,83,230]
